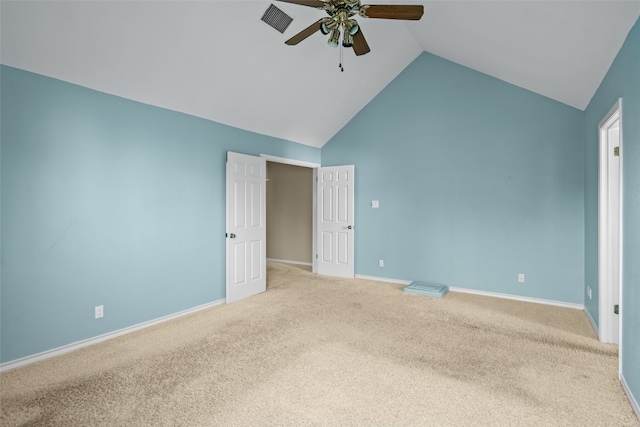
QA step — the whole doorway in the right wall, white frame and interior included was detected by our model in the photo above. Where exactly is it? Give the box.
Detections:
[598,99,623,353]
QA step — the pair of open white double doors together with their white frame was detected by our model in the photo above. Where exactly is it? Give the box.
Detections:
[226,152,355,302]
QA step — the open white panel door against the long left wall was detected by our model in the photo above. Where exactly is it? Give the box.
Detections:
[226,152,267,303]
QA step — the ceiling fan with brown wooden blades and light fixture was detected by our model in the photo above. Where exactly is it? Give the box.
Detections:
[278,0,424,56]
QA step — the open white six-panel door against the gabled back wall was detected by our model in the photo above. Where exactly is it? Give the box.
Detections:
[316,165,354,277]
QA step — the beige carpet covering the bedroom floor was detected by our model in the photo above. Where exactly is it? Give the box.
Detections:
[0,263,640,426]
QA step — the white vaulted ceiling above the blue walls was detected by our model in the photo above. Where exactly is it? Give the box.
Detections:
[0,0,640,147]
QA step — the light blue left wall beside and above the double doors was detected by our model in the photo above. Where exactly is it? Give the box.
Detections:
[0,66,320,362]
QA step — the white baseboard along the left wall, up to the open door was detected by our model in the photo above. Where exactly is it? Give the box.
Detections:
[0,299,225,372]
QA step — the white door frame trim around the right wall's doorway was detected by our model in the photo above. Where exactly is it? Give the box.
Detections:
[598,99,624,354]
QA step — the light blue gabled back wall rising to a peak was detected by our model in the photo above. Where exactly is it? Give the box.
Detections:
[322,53,584,304]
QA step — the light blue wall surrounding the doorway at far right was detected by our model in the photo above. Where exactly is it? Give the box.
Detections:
[585,20,640,412]
